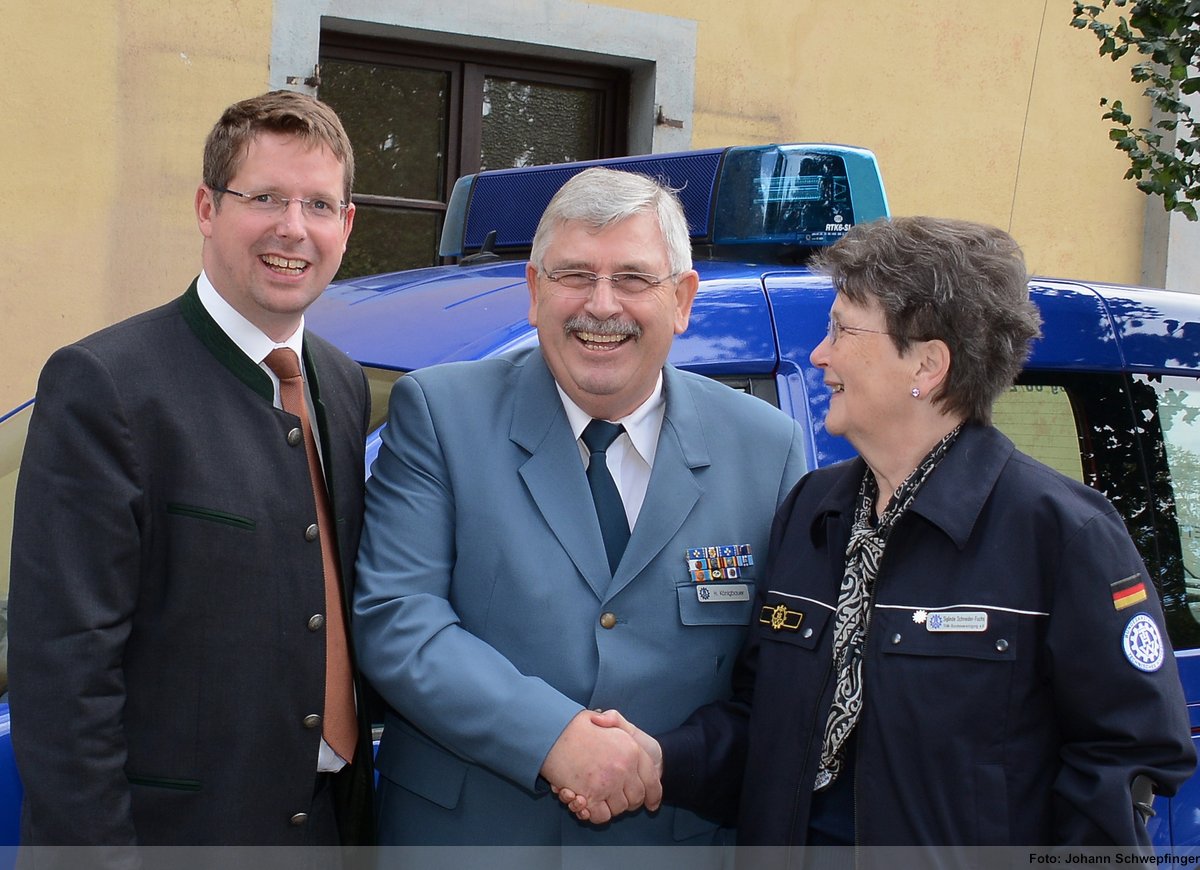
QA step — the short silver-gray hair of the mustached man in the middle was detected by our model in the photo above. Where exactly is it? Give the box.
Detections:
[529,167,691,275]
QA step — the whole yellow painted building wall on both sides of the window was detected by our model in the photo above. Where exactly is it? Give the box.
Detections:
[0,0,1146,413]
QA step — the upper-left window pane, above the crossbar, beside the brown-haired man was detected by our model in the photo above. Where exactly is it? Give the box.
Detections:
[320,60,450,200]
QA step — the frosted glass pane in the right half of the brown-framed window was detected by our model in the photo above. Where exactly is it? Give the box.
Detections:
[480,76,601,169]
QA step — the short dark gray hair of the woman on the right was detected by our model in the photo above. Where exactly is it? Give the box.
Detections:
[812,217,1042,424]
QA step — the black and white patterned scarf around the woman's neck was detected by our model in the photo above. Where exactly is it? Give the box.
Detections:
[814,425,962,791]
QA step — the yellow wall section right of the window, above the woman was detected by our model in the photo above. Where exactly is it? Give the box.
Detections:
[608,0,1147,283]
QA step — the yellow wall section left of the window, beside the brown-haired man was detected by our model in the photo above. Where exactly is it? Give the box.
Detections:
[0,0,271,413]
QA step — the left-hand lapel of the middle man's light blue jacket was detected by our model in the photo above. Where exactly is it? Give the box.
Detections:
[509,350,608,599]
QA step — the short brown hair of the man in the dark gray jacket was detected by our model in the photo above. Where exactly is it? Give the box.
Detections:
[204,90,354,203]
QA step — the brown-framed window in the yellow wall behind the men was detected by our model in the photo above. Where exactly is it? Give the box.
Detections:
[318,32,629,278]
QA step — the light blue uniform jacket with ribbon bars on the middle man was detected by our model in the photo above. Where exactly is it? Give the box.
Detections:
[354,348,804,846]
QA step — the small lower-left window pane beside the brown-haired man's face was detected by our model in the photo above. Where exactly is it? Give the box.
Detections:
[337,204,442,280]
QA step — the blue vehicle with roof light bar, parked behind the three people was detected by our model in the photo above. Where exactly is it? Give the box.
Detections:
[0,145,1200,847]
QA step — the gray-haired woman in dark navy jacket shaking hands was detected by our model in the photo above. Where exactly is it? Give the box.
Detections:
[575,217,1195,846]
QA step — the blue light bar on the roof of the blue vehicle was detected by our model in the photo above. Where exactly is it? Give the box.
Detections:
[439,145,888,257]
